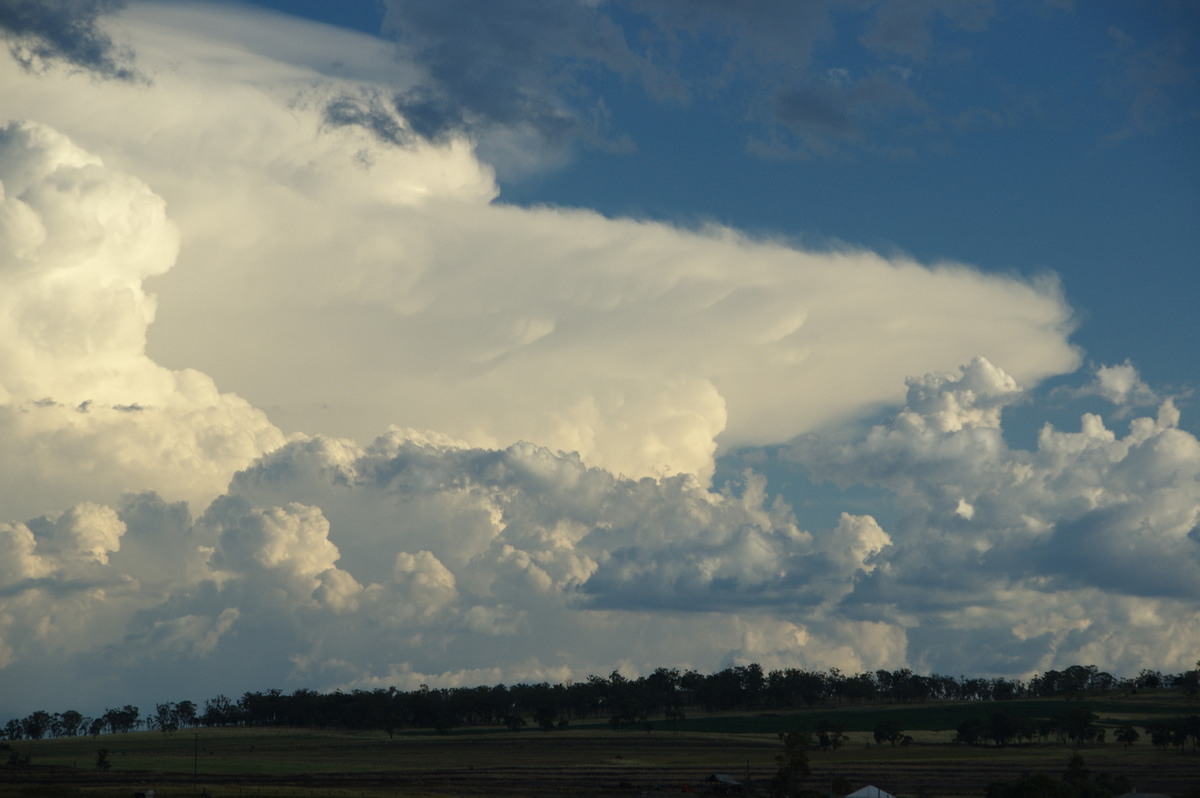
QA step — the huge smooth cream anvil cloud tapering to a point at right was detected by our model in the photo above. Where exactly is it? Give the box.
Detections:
[6,6,1078,490]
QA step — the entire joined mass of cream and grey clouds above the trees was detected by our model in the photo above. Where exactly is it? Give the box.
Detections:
[0,4,1200,712]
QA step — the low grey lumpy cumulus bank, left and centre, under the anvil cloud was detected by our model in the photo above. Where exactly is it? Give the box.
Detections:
[0,433,902,715]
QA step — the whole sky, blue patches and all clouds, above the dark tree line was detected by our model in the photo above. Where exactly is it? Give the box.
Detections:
[0,0,1200,718]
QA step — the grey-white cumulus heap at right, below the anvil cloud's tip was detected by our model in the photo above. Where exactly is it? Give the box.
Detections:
[792,359,1200,671]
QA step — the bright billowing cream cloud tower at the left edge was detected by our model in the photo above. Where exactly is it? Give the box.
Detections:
[0,122,283,517]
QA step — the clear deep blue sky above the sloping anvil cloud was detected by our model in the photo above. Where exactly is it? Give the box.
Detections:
[248,1,1200,396]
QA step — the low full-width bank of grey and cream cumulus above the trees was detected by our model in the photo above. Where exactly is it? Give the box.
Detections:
[0,359,1200,715]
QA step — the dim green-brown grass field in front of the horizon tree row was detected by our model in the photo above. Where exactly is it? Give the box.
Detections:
[0,691,1200,798]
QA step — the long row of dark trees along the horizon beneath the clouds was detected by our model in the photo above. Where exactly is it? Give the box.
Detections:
[0,662,1200,745]
